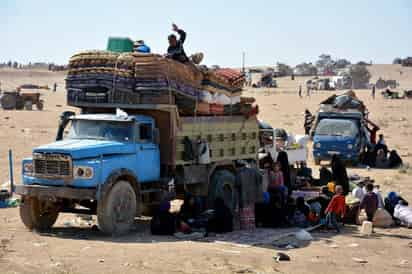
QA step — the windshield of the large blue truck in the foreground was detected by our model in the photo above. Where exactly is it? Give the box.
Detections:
[67,120,133,142]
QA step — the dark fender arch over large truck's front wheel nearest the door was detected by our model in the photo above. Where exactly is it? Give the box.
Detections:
[97,168,141,213]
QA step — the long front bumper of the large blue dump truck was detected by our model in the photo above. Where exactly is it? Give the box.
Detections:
[15,185,97,200]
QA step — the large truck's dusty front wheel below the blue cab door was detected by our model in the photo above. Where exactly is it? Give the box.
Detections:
[97,181,137,235]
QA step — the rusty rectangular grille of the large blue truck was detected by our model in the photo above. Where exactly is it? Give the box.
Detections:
[33,153,72,178]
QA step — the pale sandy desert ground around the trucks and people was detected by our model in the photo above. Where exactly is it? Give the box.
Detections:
[0,65,412,273]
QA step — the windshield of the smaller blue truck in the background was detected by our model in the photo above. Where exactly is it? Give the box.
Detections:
[315,119,359,137]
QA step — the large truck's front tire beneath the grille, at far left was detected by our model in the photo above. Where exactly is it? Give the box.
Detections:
[20,196,59,231]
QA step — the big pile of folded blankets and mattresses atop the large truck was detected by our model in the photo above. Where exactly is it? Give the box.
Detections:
[66,51,257,116]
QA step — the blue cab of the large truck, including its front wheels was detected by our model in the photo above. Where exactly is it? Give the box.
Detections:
[16,114,164,233]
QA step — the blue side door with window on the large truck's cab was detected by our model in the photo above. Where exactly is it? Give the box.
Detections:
[136,121,160,182]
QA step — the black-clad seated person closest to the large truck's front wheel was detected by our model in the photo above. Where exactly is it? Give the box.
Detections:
[150,201,176,235]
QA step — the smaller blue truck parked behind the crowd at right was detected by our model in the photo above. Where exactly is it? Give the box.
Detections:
[311,105,369,165]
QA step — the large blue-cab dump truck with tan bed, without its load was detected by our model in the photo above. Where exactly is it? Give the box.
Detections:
[15,104,259,235]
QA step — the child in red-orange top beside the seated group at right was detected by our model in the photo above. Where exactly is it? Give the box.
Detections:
[325,185,346,233]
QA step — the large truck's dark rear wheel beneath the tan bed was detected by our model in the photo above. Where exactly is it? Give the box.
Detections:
[208,170,238,213]
